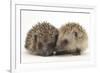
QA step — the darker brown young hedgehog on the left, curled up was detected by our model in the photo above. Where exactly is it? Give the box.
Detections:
[25,22,58,56]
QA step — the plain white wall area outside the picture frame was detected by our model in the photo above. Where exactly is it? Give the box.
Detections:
[0,0,100,73]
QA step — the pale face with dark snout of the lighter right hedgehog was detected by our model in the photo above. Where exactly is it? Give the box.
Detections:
[57,32,78,51]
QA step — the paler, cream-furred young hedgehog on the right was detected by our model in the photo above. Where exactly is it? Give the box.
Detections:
[56,22,88,55]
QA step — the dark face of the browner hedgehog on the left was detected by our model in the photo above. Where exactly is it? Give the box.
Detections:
[36,35,57,56]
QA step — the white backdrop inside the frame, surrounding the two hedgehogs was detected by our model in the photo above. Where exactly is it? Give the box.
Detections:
[21,8,90,64]
